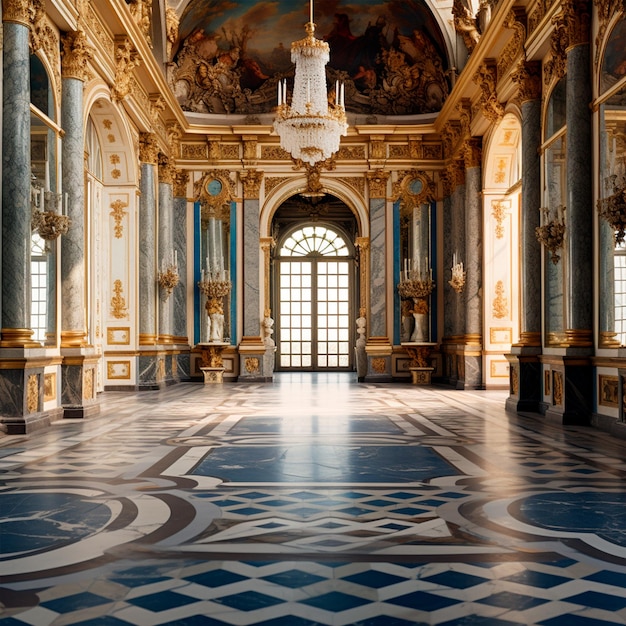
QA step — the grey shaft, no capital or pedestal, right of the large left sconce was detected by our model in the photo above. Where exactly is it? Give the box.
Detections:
[61,76,87,347]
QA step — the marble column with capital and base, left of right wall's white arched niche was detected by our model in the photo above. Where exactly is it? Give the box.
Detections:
[463,138,483,389]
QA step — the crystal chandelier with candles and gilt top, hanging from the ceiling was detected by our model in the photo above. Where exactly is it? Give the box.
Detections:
[274,0,348,165]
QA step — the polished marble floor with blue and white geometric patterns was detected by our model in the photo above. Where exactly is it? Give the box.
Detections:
[0,374,626,626]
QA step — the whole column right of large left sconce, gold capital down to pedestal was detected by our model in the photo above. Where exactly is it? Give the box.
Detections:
[60,31,100,418]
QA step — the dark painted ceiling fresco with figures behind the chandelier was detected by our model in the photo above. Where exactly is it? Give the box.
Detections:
[169,0,449,115]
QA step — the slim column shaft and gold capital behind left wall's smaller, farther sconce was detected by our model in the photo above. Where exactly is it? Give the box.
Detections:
[157,154,173,343]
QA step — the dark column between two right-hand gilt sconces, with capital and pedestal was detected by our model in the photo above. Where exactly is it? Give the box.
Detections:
[546,0,595,424]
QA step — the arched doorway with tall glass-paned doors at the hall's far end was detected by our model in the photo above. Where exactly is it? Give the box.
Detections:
[273,196,358,371]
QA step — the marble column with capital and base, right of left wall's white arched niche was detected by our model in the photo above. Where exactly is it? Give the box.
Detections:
[138,133,162,389]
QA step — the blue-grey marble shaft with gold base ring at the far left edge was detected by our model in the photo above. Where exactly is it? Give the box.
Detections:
[1,18,31,346]
